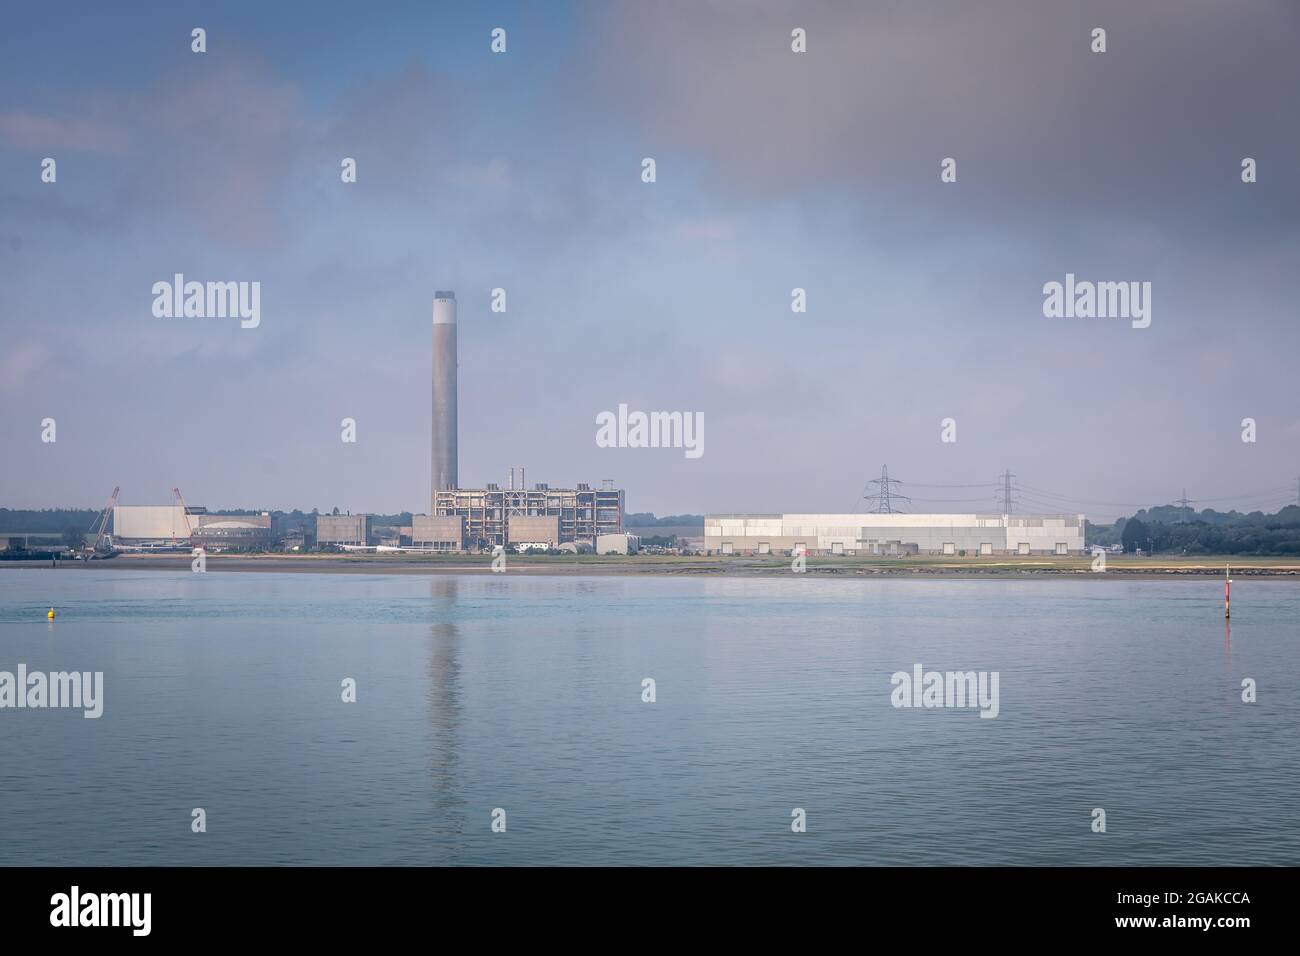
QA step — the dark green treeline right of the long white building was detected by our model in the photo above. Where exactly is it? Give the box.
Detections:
[1088,505,1300,555]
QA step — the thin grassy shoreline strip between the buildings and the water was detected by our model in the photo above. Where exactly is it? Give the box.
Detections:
[0,554,1300,581]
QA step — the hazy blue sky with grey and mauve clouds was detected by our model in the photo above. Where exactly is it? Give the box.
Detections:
[0,0,1300,519]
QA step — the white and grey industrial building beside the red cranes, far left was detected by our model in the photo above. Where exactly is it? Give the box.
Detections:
[112,505,270,551]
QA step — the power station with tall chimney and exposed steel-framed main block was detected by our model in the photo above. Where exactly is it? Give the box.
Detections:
[411,291,624,551]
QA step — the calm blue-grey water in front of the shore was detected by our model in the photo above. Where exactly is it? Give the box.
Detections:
[0,570,1300,865]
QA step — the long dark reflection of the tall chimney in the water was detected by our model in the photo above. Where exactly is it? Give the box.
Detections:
[429,575,464,862]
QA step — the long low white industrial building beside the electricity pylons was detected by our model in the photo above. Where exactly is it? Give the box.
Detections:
[705,514,1086,555]
